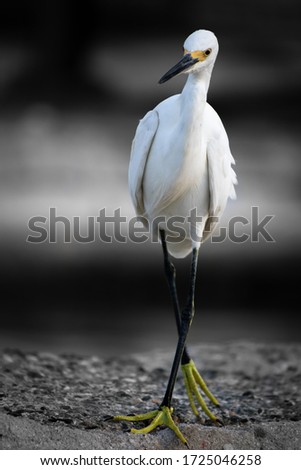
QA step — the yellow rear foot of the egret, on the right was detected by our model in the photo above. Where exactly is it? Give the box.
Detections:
[182,360,222,424]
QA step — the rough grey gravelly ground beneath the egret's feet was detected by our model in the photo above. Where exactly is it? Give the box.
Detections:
[0,343,301,449]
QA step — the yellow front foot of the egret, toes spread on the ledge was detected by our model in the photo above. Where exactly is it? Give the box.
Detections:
[113,406,188,446]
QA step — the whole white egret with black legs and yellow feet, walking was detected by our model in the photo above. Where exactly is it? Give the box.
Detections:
[114,30,236,444]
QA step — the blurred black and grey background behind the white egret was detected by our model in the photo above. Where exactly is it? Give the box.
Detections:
[0,0,301,357]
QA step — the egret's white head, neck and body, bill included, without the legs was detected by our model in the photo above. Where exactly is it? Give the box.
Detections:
[129,30,236,258]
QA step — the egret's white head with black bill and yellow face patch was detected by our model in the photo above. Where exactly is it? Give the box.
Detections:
[159,29,218,83]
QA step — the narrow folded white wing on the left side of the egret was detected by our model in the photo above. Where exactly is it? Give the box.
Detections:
[129,110,159,215]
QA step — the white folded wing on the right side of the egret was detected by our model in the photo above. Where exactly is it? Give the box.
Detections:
[205,104,237,237]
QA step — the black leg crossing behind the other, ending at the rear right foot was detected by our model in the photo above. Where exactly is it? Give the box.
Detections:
[160,230,190,365]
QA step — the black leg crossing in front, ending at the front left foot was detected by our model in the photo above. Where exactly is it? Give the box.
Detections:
[161,244,198,407]
